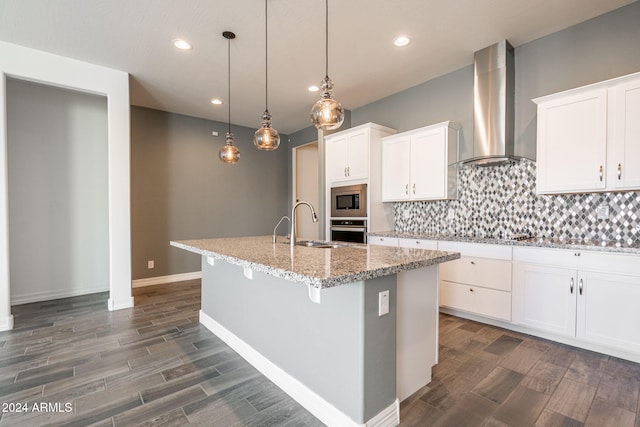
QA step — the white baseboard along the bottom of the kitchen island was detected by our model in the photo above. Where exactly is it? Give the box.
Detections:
[200,310,400,427]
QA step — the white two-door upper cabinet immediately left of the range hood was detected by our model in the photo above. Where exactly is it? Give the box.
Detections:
[382,122,459,202]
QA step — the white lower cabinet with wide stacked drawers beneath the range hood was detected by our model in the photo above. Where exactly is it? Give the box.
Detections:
[438,242,512,321]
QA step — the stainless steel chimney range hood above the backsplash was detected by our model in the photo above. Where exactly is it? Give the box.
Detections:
[461,40,520,166]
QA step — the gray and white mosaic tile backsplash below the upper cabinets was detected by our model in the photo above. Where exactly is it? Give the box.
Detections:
[394,159,640,243]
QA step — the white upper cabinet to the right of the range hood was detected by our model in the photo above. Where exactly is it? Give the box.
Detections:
[534,73,640,194]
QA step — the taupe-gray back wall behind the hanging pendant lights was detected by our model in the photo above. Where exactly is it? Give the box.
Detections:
[131,107,288,279]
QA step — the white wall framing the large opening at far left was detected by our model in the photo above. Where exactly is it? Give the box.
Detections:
[0,42,133,330]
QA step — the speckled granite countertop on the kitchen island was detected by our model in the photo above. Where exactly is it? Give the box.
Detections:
[171,236,460,288]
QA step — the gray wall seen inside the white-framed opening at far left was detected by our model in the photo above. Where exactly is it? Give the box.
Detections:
[7,78,109,304]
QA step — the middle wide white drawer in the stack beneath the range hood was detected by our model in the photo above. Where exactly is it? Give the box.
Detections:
[440,256,511,291]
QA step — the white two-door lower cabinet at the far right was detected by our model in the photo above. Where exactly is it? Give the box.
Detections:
[513,248,640,353]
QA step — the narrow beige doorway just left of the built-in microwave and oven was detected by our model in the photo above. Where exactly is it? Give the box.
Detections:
[293,141,322,240]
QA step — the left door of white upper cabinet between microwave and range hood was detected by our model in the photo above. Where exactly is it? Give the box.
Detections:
[382,136,411,202]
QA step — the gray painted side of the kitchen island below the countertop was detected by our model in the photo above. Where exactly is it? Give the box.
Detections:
[202,257,396,423]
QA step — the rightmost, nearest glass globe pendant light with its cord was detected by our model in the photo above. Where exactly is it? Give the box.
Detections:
[311,0,344,130]
